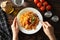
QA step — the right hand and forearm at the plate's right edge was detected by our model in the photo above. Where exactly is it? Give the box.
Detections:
[42,22,56,40]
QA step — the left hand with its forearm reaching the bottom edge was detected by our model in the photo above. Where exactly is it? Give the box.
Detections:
[11,18,19,40]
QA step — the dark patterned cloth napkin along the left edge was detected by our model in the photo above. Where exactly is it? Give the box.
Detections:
[0,8,11,40]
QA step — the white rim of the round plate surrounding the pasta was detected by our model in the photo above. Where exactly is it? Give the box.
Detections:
[17,7,43,34]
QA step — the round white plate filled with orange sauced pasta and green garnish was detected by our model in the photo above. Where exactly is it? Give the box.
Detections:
[17,7,43,34]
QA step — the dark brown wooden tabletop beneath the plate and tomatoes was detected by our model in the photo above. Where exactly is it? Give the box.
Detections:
[0,0,60,40]
